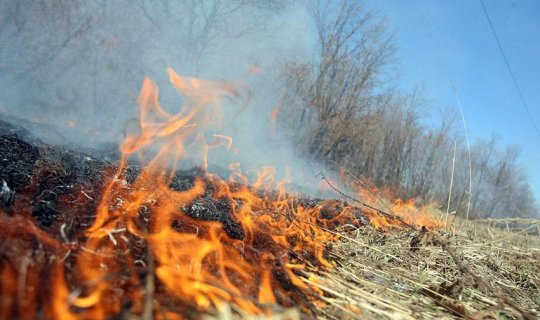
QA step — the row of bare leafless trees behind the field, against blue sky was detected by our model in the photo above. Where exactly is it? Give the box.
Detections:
[281,1,538,217]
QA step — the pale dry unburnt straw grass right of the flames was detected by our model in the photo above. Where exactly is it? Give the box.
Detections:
[306,214,540,319]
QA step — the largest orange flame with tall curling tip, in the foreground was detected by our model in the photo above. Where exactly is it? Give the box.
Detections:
[52,69,362,317]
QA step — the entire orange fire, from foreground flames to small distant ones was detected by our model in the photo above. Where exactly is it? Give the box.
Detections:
[0,69,442,319]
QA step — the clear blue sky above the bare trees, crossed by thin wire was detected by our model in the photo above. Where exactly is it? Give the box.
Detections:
[366,0,540,202]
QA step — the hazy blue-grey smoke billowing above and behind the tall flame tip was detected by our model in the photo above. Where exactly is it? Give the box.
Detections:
[0,0,332,192]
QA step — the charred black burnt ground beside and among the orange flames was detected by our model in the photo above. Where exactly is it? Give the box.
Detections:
[0,121,367,239]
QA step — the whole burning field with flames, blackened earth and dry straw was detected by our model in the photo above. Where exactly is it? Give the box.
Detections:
[0,70,539,319]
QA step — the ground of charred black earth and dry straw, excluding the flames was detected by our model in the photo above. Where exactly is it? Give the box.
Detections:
[0,122,540,320]
